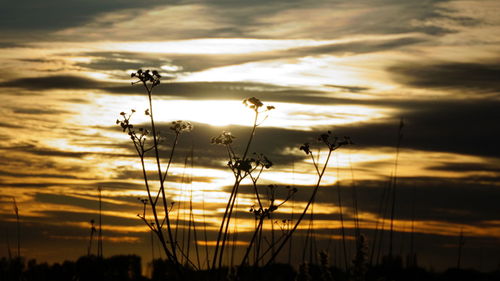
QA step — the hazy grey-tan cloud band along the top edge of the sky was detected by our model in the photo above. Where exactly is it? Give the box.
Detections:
[5,0,466,40]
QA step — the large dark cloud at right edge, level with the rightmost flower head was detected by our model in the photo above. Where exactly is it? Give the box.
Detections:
[324,100,500,157]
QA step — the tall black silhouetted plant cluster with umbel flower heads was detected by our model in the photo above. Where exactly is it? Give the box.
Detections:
[116,70,358,276]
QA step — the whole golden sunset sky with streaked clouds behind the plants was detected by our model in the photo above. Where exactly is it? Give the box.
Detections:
[0,0,500,270]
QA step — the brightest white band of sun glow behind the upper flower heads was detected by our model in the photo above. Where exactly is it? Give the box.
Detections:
[88,93,394,131]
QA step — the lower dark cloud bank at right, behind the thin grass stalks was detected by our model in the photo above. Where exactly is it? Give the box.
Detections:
[232,175,500,226]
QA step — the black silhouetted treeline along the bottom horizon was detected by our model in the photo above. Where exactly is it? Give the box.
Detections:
[0,255,500,281]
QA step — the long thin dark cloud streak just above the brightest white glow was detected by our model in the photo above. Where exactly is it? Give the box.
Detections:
[0,72,367,105]
